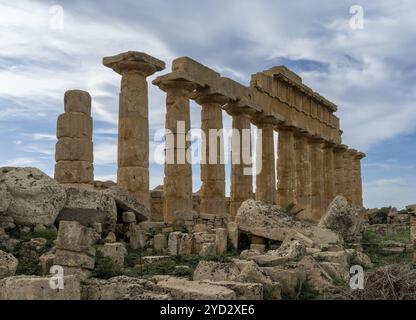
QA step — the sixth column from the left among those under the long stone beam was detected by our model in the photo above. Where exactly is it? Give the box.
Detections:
[295,130,311,218]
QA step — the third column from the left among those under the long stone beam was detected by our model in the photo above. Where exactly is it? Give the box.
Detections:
[226,103,253,220]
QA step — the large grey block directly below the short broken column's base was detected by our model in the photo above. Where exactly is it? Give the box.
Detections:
[57,186,117,233]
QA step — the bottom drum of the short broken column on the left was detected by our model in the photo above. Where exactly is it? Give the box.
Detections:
[55,161,94,184]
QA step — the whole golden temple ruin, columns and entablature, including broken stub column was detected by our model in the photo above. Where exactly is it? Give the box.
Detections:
[55,51,365,255]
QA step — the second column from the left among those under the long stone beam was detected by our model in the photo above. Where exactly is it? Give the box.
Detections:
[195,92,227,217]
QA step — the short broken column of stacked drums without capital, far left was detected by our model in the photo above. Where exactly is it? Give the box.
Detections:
[55,90,94,184]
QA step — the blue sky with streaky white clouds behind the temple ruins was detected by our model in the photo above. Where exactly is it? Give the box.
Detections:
[0,0,416,207]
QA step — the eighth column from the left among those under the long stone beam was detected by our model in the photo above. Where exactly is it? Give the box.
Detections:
[322,141,336,210]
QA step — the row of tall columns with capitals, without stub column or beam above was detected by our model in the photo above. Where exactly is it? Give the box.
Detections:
[99,52,364,221]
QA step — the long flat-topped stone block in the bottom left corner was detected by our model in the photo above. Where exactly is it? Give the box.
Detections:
[0,276,81,300]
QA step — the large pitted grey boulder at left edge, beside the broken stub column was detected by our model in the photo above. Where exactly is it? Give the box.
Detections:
[0,168,66,227]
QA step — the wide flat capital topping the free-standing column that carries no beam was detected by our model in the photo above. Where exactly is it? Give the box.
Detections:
[103,51,166,77]
